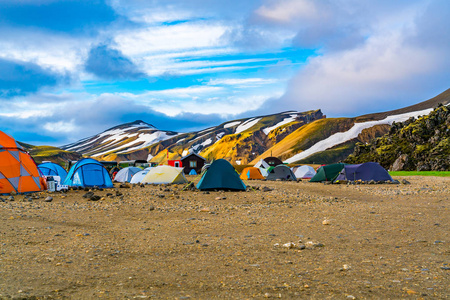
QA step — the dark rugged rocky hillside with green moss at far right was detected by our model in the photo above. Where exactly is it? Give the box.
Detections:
[345,105,450,171]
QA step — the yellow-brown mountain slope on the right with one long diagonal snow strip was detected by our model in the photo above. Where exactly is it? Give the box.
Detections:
[250,89,450,164]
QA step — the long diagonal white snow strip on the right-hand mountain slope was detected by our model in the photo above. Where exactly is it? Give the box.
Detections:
[285,108,433,164]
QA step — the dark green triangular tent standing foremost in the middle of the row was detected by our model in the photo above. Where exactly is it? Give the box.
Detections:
[197,159,246,191]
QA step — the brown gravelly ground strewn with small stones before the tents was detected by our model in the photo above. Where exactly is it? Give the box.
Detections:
[0,177,450,299]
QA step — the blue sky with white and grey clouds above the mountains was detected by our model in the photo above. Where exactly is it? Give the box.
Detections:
[0,0,450,146]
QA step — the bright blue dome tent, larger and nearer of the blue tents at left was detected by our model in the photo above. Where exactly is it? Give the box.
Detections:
[63,158,113,188]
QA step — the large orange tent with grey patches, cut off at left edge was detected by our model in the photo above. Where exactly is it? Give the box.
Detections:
[0,131,43,194]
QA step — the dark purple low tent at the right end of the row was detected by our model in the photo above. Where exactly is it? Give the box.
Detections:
[334,162,392,182]
